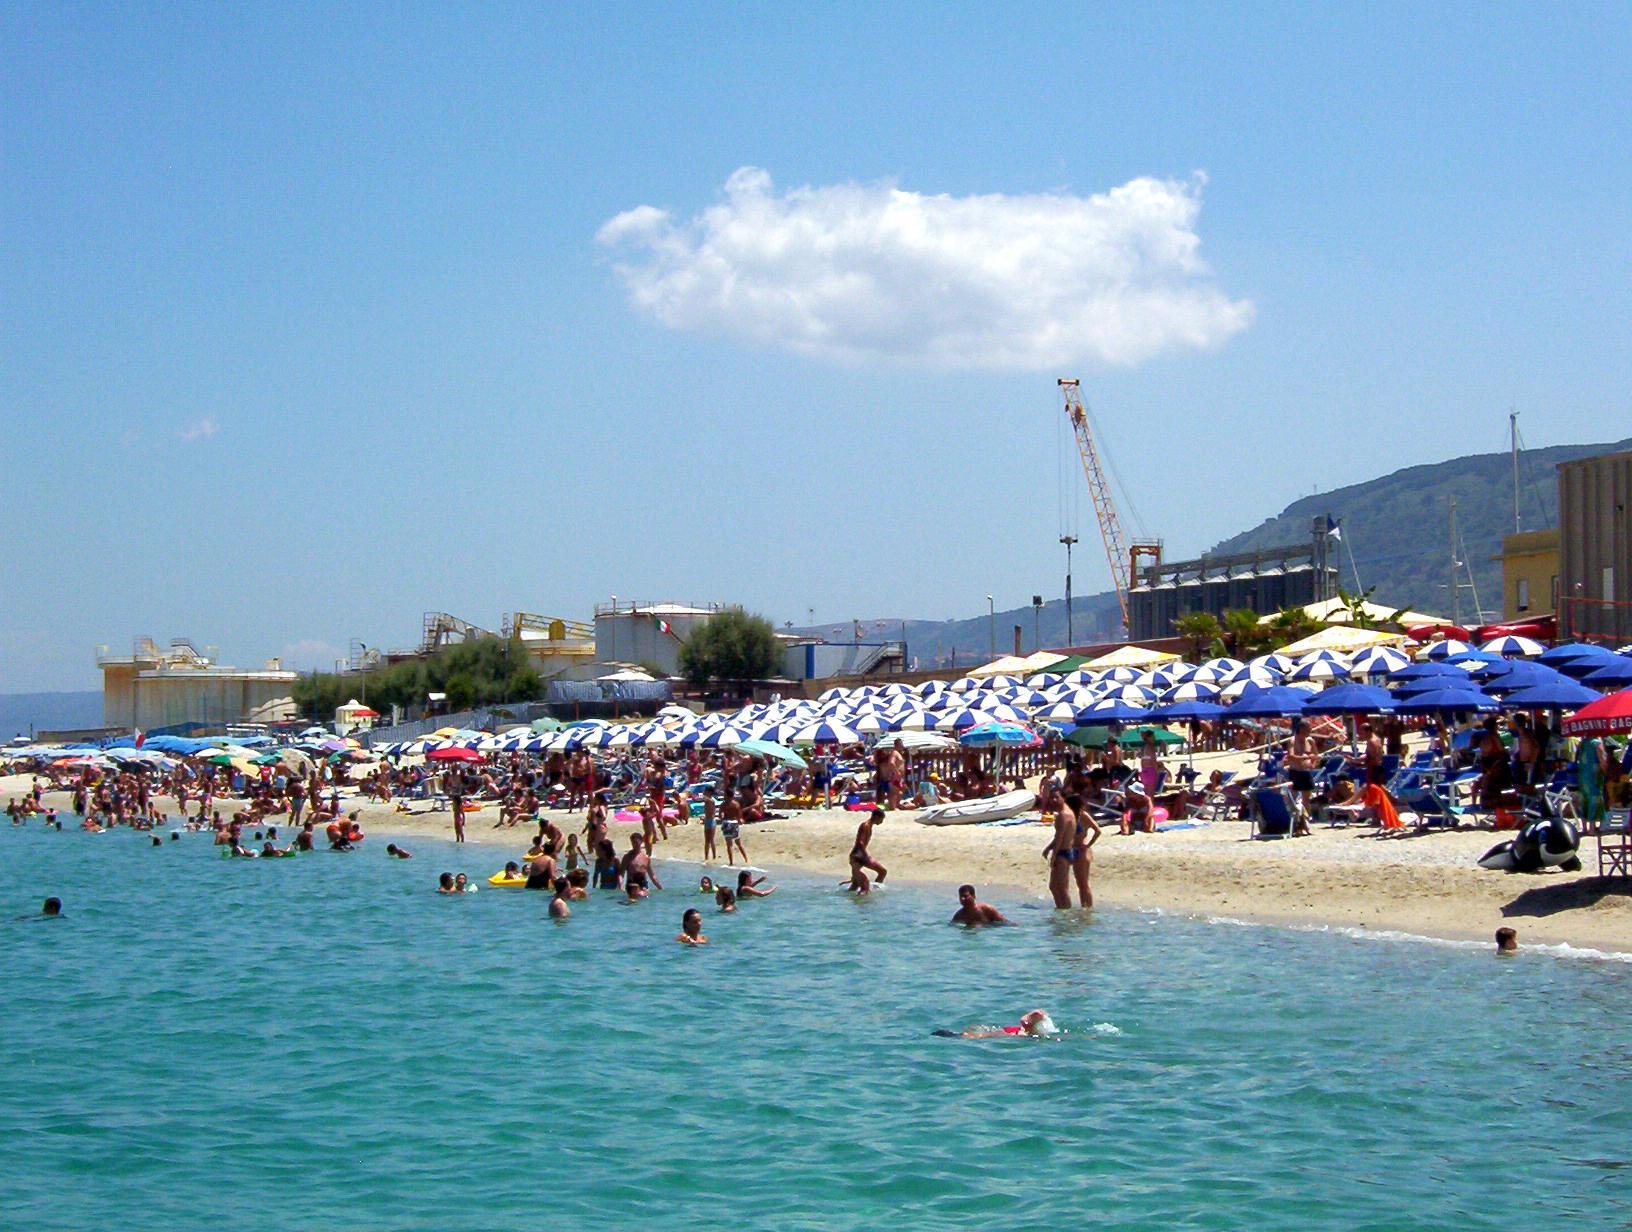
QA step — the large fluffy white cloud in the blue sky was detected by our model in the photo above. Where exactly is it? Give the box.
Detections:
[596,166,1253,369]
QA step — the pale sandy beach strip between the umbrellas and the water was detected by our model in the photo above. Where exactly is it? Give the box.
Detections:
[22,775,1632,953]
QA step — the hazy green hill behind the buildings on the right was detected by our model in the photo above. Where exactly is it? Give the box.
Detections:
[1213,441,1632,620]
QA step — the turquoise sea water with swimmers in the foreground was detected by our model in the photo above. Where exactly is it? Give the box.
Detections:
[0,824,1632,1232]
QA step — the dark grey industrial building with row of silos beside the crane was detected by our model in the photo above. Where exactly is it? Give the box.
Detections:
[1128,517,1337,641]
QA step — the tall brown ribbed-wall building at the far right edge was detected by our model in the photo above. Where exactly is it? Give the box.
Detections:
[1553,450,1632,645]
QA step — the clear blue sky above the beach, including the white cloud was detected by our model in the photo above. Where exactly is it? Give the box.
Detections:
[0,5,1632,692]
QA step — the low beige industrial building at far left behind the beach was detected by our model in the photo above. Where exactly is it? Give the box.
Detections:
[96,638,299,731]
